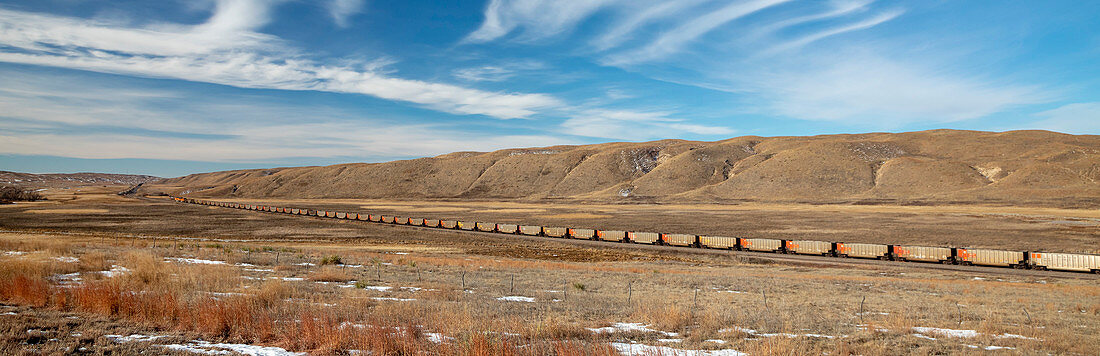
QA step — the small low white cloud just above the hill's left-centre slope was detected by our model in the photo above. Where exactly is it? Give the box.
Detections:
[561,109,735,141]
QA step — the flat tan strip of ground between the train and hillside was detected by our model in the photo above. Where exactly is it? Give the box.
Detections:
[207,195,1100,254]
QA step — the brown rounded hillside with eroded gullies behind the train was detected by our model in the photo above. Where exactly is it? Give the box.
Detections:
[145,130,1100,207]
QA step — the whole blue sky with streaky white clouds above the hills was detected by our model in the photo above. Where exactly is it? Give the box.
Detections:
[0,0,1100,177]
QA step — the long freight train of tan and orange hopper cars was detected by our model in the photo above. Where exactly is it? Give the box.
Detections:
[173,197,1100,274]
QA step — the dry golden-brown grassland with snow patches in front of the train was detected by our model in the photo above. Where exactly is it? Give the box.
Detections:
[0,187,1100,355]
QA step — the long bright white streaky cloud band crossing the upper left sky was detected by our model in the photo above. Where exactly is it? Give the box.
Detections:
[0,0,561,119]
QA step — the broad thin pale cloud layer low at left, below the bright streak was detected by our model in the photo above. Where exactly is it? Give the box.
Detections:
[0,71,578,163]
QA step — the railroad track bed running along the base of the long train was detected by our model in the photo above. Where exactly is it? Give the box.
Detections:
[165,197,1100,279]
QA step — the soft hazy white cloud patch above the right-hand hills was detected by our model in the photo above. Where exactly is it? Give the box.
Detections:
[748,53,1049,124]
